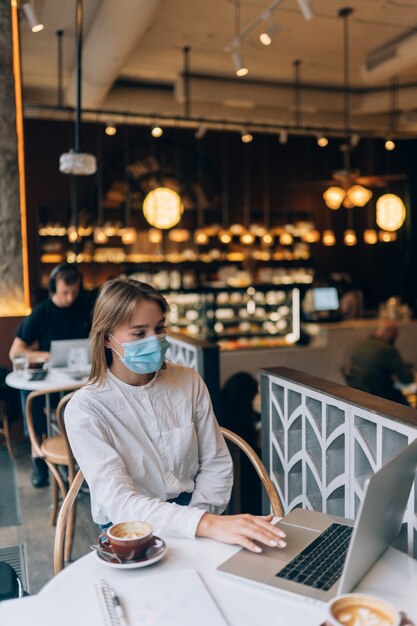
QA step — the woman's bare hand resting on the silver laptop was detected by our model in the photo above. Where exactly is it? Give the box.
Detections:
[196,513,287,552]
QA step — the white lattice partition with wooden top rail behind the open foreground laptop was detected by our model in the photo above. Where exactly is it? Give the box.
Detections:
[261,368,417,557]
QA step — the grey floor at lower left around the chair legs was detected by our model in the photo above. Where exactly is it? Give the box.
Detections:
[0,444,98,594]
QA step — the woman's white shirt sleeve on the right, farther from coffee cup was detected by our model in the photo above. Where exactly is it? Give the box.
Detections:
[190,377,233,514]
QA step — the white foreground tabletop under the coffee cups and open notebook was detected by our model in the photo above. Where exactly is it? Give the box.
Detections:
[32,537,417,626]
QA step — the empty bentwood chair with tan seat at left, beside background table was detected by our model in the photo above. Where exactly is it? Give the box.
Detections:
[26,385,80,525]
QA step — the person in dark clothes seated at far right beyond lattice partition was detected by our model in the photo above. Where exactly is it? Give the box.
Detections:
[350,319,414,405]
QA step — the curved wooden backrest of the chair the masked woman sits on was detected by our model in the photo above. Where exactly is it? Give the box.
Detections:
[54,428,283,574]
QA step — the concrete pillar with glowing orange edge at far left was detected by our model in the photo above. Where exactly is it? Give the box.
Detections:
[0,0,29,317]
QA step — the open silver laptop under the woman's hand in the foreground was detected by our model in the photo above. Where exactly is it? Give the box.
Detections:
[218,439,417,602]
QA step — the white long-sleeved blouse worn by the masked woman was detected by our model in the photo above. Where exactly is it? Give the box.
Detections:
[65,364,233,537]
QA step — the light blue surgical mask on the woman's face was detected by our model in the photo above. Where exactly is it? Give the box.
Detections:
[109,333,169,374]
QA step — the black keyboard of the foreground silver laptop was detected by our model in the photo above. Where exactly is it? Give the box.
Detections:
[275,524,353,591]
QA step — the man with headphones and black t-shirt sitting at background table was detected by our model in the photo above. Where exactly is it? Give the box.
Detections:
[9,263,93,487]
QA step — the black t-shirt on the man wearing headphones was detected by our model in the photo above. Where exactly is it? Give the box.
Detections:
[16,291,94,352]
